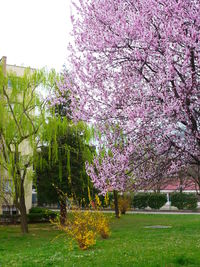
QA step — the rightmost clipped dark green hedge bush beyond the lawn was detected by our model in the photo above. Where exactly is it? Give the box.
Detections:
[171,193,197,210]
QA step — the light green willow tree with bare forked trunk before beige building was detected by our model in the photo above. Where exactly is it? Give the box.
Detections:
[0,66,47,233]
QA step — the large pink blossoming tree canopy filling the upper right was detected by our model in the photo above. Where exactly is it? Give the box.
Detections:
[57,0,200,195]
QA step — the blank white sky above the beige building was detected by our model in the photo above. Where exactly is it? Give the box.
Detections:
[0,0,72,71]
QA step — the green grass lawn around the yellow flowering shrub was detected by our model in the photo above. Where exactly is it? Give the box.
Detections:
[0,214,200,267]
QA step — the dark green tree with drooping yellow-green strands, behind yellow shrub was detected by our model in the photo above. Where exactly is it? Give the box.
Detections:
[35,114,94,224]
